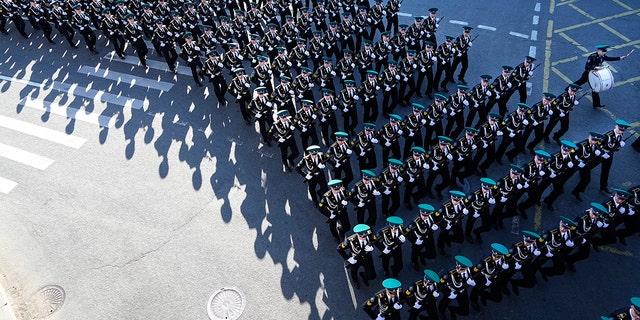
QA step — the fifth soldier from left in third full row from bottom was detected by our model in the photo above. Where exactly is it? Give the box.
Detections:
[427,136,454,200]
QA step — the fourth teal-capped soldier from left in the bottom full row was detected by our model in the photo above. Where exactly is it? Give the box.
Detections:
[469,243,511,312]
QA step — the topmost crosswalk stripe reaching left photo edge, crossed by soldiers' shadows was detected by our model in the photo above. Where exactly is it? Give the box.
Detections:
[0,74,149,109]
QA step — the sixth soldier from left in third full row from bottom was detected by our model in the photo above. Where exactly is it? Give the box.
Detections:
[451,127,478,189]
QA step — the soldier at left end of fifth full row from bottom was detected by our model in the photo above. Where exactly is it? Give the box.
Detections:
[269,110,300,172]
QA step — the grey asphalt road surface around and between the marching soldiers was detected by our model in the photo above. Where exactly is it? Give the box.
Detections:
[0,0,640,319]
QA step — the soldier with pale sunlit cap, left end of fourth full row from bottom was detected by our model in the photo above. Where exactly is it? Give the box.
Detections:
[296,145,324,208]
